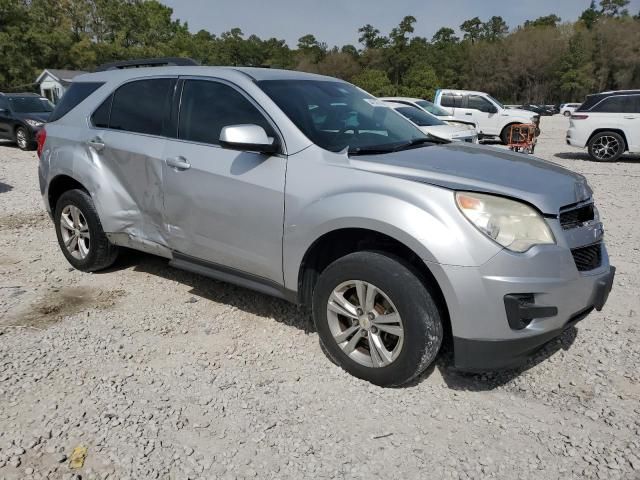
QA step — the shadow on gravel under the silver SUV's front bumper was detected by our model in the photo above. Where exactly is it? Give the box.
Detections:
[432,326,578,392]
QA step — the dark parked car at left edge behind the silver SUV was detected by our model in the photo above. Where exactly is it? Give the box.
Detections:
[0,93,53,150]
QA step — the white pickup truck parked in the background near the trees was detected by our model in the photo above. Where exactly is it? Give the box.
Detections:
[433,90,540,143]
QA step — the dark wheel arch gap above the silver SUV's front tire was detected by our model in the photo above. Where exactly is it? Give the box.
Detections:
[298,227,451,338]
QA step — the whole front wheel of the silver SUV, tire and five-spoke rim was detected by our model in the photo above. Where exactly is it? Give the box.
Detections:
[313,252,444,387]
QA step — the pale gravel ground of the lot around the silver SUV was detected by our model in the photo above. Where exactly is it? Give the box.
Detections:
[0,117,640,479]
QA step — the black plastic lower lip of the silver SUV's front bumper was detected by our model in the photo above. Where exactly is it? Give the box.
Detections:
[453,266,616,371]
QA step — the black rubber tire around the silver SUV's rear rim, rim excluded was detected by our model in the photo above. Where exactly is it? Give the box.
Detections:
[54,190,119,272]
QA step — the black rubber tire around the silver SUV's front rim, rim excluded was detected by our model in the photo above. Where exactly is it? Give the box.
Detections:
[313,251,444,387]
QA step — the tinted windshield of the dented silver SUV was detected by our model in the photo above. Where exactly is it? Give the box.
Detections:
[258,80,428,152]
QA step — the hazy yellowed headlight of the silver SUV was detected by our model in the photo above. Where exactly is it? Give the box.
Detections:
[456,192,556,252]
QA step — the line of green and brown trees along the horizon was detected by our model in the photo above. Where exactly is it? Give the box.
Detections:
[0,0,640,103]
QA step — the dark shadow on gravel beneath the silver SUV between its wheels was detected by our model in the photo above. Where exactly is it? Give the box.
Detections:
[101,249,315,333]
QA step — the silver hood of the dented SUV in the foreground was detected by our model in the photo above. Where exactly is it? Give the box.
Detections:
[351,142,592,215]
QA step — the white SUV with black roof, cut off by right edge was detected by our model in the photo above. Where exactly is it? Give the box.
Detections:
[567,90,640,162]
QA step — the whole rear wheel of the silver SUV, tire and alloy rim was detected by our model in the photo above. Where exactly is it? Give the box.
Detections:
[54,190,118,272]
